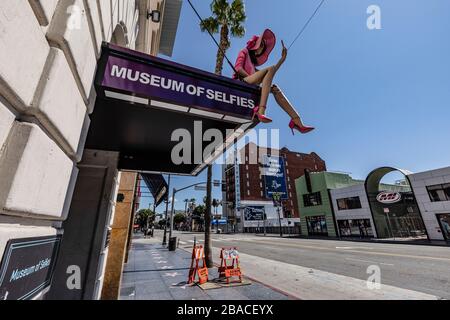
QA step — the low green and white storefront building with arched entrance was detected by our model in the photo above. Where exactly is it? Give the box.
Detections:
[296,167,450,241]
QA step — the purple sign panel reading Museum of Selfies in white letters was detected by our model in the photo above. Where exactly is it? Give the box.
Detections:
[102,55,259,118]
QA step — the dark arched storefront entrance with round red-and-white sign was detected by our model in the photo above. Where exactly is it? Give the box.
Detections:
[365,167,428,239]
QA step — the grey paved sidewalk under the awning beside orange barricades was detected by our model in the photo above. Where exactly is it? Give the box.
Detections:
[120,236,289,300]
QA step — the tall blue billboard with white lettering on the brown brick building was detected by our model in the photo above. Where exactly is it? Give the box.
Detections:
[263,155,289,200]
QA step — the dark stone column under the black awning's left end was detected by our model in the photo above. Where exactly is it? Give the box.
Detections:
[46,150,119,300]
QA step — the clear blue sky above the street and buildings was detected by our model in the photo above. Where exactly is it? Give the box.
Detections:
[139,0,450,215]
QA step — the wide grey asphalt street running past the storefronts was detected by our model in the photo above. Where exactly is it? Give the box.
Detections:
[156,230,450,299]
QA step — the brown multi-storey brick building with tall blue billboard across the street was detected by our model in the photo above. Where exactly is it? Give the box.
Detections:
[223,143,326,233]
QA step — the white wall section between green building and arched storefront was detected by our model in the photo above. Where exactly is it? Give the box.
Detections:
[330,184,377,237]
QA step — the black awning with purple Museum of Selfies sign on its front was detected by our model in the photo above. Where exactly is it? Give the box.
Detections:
[86,44,260,175]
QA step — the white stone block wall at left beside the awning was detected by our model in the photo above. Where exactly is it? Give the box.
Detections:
[0,0,159,298]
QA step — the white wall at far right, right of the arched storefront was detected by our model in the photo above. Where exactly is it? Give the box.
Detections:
[408,167,450,240]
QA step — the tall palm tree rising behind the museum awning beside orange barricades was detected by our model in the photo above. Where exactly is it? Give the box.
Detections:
[200,0,247,268]
